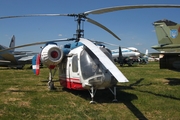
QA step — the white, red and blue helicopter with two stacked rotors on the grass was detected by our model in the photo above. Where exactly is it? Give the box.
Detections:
[0,5,180,103]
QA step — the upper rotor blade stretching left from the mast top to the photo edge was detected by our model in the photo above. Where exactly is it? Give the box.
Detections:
[0,14,71,19]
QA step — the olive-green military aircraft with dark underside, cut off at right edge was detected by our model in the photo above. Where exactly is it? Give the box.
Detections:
[152,19,180,69]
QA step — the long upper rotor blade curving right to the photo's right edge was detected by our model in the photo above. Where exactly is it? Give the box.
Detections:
[84,4,180,14]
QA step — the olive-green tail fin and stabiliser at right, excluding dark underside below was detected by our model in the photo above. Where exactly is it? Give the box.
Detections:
[152,19,180,52]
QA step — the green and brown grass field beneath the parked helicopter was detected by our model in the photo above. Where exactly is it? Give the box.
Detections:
[0,62,180,120]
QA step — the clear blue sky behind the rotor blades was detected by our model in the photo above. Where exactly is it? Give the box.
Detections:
[0,0,180,52]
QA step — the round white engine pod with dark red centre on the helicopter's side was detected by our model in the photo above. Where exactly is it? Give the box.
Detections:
[41,44,63,69]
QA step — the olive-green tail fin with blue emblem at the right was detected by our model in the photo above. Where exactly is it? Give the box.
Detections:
[153,20,180,45]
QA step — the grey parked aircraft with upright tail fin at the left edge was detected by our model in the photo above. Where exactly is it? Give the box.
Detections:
[0,35,37,69]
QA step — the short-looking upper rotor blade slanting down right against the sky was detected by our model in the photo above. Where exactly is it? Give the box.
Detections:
[86,17,121,40]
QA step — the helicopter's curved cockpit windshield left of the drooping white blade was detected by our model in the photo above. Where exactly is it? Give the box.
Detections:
[80,50,102,80]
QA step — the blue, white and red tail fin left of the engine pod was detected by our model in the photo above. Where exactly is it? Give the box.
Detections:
[32,54,40,75]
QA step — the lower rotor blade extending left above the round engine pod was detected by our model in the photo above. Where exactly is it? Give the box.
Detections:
[0,38,75,52]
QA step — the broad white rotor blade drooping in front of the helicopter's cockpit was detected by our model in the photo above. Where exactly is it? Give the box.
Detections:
[80,38,128,82]
